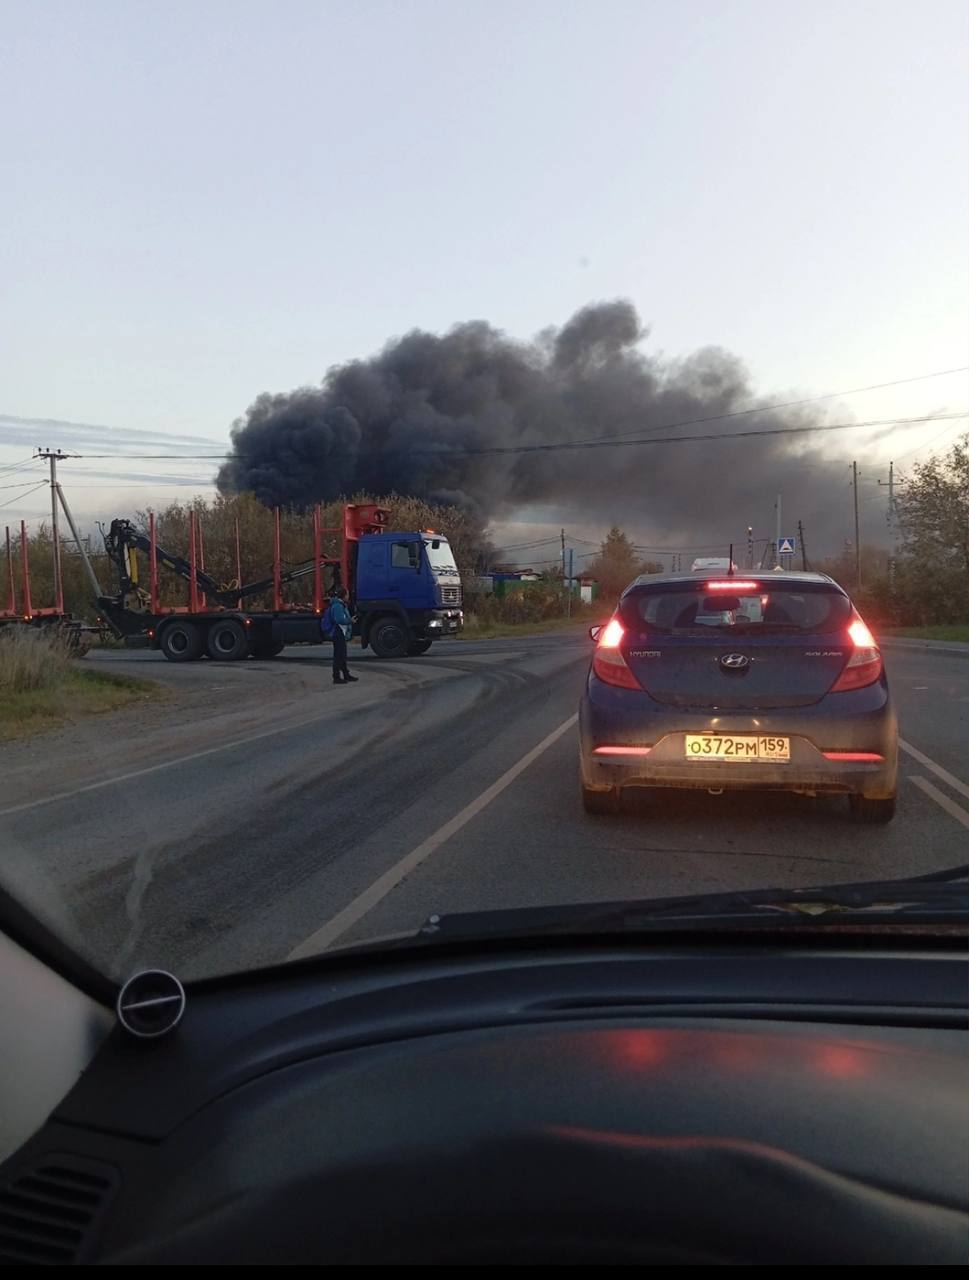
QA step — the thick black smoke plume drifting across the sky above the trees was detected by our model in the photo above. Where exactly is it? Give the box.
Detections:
[218,301,885,554]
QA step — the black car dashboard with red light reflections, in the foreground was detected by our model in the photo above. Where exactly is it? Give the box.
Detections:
[0,934,969,1265]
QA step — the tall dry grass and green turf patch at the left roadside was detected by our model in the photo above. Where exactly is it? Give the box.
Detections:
[0,626,163,741]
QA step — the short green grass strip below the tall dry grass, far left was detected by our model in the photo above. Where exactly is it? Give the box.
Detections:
[0,668,166,742]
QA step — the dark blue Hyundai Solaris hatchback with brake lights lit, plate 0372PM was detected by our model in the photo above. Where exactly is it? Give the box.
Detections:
[579,570,899,822]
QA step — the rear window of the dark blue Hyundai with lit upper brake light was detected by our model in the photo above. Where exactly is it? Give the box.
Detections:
[621,580,851,635]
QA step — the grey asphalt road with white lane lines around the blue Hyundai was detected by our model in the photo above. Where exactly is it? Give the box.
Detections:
[0,632,969,978]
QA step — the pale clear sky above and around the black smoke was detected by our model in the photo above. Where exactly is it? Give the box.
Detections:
[0,0,969,524]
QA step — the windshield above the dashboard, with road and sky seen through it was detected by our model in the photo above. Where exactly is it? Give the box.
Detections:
[0,0,969,980]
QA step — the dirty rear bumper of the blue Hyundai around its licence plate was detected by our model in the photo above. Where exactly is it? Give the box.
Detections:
[580,677,899,799]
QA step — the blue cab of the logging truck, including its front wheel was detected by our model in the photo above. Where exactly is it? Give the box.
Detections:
[353,530,465,658]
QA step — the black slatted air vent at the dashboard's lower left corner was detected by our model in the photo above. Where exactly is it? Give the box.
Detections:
[0,1156,118,1266]
